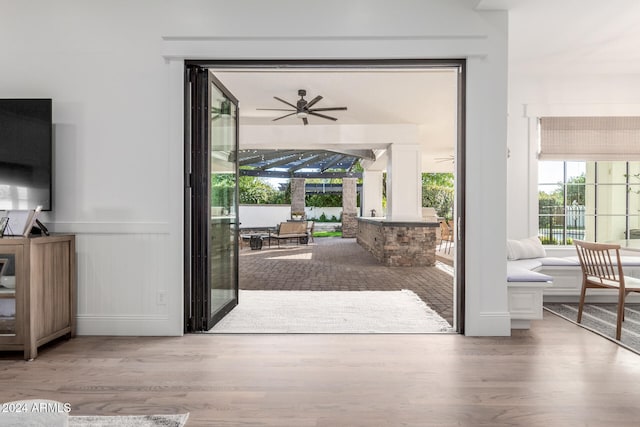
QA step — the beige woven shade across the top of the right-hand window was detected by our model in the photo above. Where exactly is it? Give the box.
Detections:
[539,117,640,160]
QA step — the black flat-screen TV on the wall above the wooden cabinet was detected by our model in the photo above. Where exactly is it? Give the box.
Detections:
[0,99,53,211]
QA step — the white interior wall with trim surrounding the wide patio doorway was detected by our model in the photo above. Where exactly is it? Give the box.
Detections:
[0,0,510,335]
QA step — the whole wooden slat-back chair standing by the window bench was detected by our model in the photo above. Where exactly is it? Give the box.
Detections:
[573,240,640,340]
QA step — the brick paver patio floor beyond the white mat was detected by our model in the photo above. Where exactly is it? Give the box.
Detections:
[240,238,454,325]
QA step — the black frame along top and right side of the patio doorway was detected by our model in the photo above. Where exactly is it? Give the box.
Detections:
[184,58,467,334]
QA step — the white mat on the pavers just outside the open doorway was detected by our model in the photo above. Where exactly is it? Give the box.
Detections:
[209,289,454,334]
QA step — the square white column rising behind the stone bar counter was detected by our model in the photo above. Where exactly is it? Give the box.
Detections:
[387,144,422,221]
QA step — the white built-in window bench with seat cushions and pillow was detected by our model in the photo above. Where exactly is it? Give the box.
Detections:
[507,241,640,329]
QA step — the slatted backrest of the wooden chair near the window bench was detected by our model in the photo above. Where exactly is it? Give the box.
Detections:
[573,240,624,286]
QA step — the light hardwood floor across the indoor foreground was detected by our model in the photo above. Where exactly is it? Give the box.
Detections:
[0,313,640,427]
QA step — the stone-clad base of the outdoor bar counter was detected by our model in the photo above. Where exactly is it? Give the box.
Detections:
[357,218,438,267]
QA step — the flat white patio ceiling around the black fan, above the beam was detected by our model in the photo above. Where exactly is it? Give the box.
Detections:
[212,69,457,127]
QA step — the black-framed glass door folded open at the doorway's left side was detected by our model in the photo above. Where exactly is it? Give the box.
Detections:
[185,66,238,331]
